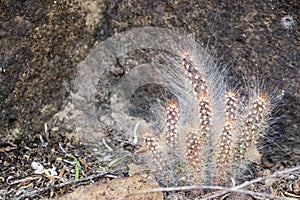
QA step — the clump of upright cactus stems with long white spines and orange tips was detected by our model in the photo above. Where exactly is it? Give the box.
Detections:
[142,51,271,186]
